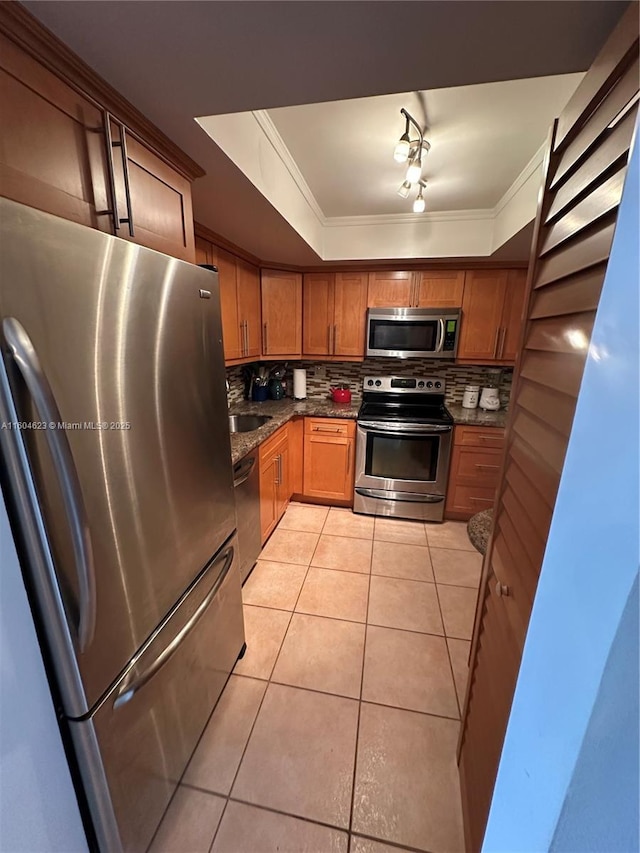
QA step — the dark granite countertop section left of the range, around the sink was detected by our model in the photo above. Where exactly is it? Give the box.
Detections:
[229,398,361,465]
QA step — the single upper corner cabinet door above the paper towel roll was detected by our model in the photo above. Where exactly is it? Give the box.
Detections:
[262,270,302,358]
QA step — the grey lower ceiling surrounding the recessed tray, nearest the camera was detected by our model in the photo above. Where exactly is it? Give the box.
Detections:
[24,0,628,265]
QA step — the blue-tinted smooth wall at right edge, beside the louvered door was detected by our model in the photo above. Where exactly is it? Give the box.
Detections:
[483,131,640,853]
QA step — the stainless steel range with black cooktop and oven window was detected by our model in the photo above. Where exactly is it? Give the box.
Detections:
[353,376,453,521]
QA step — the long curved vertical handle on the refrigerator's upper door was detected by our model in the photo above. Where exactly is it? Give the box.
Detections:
[2,317,96,651]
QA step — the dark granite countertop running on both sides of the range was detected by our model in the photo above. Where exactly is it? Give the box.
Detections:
[229,397,507,465]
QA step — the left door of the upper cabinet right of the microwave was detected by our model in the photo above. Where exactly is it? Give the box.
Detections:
[458,270,507,363]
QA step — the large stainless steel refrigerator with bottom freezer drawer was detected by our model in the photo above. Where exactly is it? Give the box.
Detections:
[0,199,244,853]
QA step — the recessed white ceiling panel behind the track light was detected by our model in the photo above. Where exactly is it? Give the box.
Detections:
[268,73,584,217]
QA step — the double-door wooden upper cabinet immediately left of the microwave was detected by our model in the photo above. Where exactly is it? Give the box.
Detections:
[302,272,367,361]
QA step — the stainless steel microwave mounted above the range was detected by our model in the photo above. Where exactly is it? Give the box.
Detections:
[367,308,460,359]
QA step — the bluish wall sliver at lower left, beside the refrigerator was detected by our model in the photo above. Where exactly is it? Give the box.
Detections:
[0,494,87,853]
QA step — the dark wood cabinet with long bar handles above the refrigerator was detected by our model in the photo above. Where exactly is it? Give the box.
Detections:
[0,3,203,261]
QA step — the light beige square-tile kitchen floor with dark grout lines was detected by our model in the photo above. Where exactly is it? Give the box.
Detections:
[152,504,482,853]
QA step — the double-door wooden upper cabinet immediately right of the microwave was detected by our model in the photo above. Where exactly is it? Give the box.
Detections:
[458,270,526,364]
